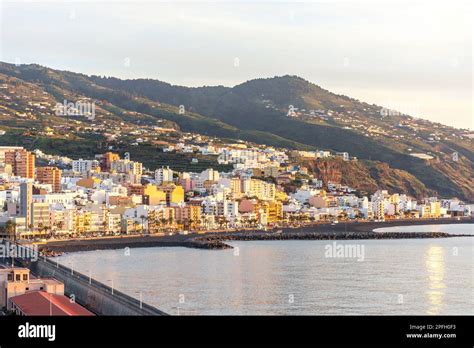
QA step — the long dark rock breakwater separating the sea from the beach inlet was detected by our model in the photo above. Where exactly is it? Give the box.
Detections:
[187,232,472,249]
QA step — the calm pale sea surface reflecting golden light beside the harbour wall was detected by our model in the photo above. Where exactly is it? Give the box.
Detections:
[58,224,474,315]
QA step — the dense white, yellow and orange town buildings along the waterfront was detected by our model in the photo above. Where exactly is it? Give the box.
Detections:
[0,141,472,242]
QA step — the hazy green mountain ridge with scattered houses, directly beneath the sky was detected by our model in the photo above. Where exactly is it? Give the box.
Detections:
[0,63,474,201]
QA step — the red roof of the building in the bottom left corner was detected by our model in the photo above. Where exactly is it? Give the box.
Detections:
[9,291,94,316]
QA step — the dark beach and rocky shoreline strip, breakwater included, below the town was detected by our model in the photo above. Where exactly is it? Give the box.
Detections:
[40,218,474,256]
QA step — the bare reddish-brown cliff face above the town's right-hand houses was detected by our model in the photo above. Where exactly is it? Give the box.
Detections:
[301,159,435,198]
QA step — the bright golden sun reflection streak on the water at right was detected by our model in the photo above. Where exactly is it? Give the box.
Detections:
[425,245,446,315]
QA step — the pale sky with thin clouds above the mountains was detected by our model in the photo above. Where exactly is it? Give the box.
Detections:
[0,0,474,129]
